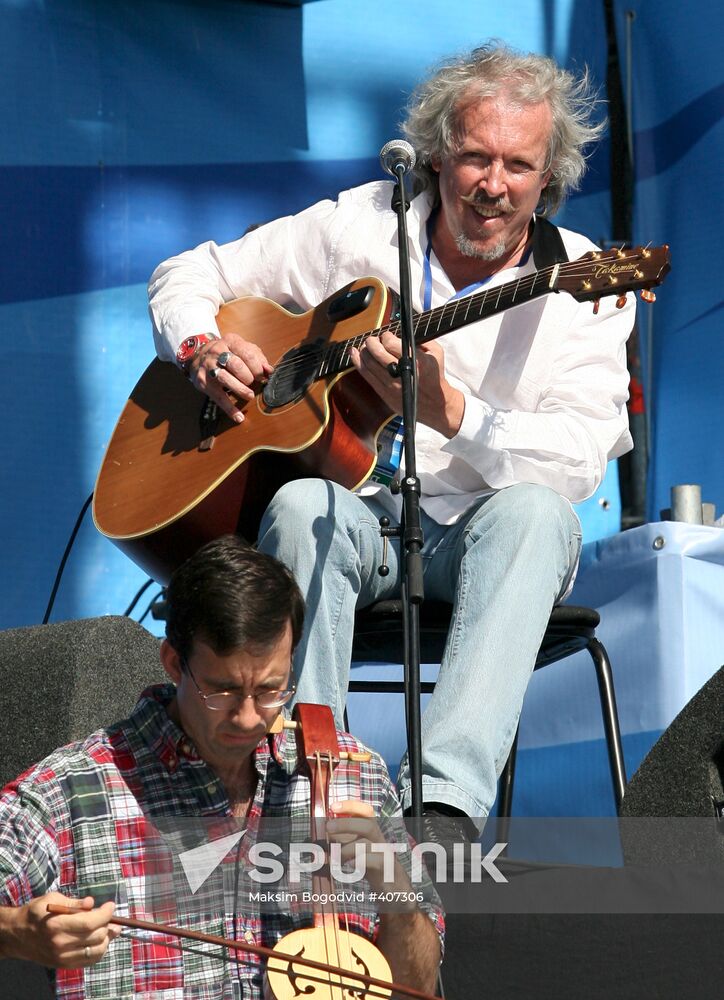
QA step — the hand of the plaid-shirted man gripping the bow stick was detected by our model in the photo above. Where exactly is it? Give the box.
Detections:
[0,892,121,969]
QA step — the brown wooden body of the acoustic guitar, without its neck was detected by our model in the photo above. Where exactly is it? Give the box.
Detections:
[93,278,392,583]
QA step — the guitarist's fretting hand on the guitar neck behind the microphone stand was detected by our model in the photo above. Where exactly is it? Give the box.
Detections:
[350,332,465,438]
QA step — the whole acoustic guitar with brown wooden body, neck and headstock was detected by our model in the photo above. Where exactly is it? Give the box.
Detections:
[93,245,670,583]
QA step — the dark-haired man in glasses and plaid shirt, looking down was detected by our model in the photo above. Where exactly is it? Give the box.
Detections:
[0,536,443,1000]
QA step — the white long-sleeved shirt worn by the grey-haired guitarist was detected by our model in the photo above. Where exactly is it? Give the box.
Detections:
[149,181,635,524]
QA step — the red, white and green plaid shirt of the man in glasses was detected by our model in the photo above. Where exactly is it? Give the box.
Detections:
[0,685,443,1000]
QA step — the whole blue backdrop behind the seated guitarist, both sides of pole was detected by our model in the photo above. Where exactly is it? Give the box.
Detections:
[0,0,724,640]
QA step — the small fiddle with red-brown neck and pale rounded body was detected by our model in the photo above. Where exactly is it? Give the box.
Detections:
[266,704,393,1000]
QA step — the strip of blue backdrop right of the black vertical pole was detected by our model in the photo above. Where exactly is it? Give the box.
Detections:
[616,0,724,520]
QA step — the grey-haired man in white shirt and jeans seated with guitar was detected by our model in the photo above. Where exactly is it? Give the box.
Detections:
[150,43,634,837]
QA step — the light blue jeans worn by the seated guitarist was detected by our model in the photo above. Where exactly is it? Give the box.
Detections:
[259,479,581,817]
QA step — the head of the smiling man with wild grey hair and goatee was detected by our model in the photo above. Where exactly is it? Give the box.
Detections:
[403,45,604,276]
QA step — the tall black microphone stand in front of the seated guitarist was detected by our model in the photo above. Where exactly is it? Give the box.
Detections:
[380,159,424,816]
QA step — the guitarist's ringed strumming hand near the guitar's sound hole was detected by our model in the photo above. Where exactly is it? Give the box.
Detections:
[188,333,274,424]
